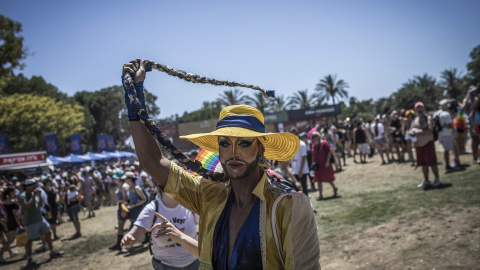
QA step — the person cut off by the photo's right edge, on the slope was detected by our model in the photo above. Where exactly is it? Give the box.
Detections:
[462,85,480,163]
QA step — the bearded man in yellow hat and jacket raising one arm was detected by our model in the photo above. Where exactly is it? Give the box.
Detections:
[123,60,320,269]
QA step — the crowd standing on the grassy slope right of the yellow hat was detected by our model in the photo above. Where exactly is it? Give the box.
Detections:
[273,86,480,200]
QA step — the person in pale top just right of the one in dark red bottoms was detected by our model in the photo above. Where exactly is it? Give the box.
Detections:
[433,99,460,172]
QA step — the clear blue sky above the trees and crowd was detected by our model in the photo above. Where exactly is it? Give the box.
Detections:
[0,0,480,117]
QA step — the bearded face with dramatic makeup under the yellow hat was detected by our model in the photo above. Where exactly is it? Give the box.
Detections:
[218,137,263,180]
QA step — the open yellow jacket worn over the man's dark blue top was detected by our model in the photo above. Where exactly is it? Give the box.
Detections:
[164,162,320,270]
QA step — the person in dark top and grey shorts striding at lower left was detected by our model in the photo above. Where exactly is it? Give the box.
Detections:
[19,179,63,267]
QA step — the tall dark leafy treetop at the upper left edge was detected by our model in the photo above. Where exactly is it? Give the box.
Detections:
[0,14,26,79]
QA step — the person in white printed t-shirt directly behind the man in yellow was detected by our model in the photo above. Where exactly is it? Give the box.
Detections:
[121,193,200,270]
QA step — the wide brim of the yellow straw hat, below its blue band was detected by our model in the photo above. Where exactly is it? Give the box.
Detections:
[180,127,300,161]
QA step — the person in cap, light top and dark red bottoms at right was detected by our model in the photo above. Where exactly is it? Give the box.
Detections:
[408,102,441,188]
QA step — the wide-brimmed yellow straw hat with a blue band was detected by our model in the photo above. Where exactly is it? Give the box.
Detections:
[180,105,300,161]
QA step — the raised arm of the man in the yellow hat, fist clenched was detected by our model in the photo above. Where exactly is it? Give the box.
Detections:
[122,59,170,188]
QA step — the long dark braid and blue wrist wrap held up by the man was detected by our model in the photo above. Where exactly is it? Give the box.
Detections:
[122,60,275,182]
